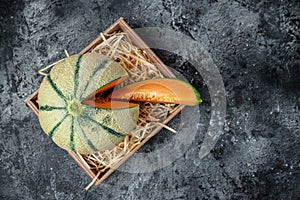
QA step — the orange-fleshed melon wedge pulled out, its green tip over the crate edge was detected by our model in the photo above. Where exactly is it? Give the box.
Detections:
[109,78,202,106]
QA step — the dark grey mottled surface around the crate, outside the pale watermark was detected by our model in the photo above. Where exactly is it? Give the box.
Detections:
[0,0,300,199]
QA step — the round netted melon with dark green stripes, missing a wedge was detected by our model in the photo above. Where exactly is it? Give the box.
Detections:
[38,53,139,154]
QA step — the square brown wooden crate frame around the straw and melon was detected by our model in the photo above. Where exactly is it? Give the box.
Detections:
[25,18,184,185]
